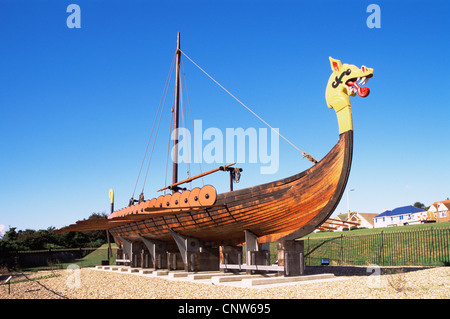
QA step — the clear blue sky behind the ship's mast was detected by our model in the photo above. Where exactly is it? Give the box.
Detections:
[0,0,450,235]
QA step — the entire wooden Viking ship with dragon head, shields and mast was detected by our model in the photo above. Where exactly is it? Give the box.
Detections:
[55,34,373,254]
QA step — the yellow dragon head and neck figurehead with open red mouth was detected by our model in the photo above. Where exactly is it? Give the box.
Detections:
[325,57,373,134]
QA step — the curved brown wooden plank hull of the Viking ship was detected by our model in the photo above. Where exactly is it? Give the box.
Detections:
[57,130,353,245]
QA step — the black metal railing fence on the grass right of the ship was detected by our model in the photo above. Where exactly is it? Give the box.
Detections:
[304,227,450,266]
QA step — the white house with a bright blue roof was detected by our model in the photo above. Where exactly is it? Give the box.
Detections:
[374,205,426,228]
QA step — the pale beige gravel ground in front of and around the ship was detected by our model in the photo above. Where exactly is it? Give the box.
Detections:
[0,266,450,299]
